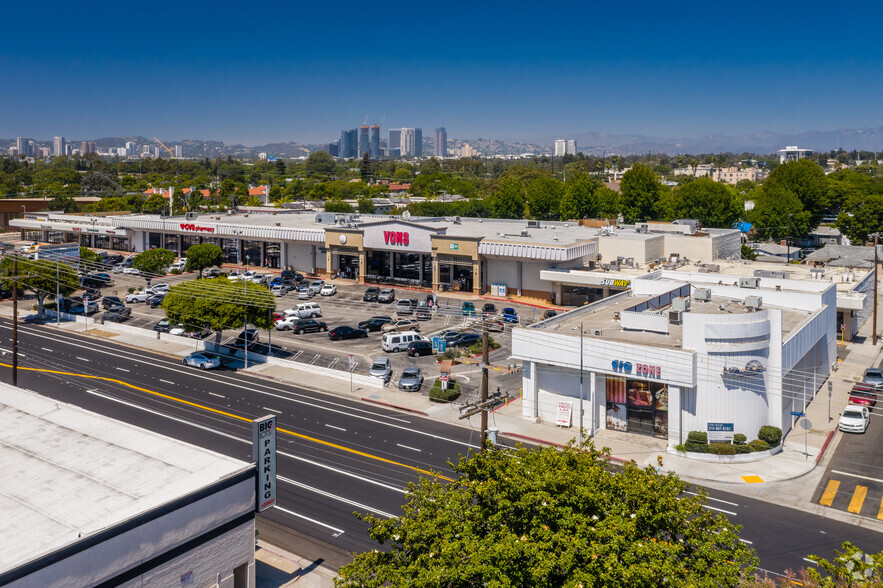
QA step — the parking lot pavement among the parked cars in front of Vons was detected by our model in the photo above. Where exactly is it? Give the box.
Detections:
[77,274,542,397]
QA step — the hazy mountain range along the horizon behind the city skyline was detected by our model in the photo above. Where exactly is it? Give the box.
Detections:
[0,126,883,157]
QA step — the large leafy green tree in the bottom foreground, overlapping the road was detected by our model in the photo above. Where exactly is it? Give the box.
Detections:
[336,443,757,588]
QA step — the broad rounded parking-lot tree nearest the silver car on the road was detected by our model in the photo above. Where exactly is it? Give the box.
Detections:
[162,278,276,335]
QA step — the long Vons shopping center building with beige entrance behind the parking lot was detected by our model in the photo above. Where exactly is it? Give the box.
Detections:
[12,209,740,305]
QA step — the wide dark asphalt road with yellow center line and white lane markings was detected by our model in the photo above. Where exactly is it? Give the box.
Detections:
[0,320,883,573]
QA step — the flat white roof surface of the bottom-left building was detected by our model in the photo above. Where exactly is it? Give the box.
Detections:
[0,384,252,573]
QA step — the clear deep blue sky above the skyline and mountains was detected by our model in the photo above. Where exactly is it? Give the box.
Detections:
[0,0,883,145]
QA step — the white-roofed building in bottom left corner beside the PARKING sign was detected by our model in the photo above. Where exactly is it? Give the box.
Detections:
[0,384,256,588]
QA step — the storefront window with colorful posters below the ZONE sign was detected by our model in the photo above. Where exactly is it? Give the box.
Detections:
[607,376,668,437]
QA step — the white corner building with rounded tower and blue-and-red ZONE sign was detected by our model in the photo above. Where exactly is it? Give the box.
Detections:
[512,264,840,448]
